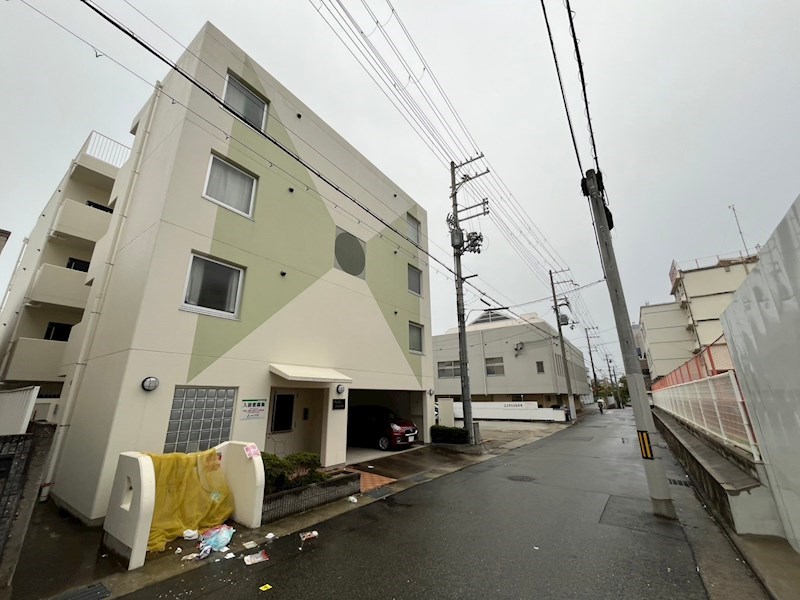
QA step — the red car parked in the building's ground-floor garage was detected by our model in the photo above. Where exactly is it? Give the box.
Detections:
[347,405,419,450]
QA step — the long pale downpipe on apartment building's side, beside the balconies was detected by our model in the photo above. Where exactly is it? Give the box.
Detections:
[39,81,162,502]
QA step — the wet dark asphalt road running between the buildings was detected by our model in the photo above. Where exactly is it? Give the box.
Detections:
[126,410,707,600]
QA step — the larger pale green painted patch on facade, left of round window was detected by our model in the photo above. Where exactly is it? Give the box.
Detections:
[188,62,336,381]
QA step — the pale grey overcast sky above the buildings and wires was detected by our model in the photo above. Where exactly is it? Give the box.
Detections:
[0,0,800,376]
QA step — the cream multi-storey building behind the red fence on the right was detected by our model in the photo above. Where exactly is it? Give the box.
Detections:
[639,255,758,381]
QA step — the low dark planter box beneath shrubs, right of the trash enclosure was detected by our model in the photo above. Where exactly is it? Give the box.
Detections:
[261,473,361,525]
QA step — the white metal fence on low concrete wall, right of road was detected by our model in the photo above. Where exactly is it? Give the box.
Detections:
[653,371,761,462]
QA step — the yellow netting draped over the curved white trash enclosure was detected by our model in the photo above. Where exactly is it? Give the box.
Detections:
[147,448,233,552]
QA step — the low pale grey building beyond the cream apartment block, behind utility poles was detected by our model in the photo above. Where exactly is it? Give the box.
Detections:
[433,310,590,408]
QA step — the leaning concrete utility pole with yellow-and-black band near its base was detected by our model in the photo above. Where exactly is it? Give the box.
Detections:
[581,169,677,519]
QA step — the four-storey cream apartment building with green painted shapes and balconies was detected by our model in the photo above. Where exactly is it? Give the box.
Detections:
[0,24,433,522]
